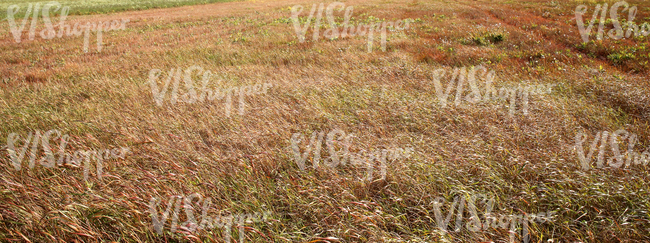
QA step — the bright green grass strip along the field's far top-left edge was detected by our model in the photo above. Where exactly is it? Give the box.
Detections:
[0,0,237,19]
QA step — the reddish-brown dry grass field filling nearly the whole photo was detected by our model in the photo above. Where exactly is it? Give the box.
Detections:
[0,0,650,242]
